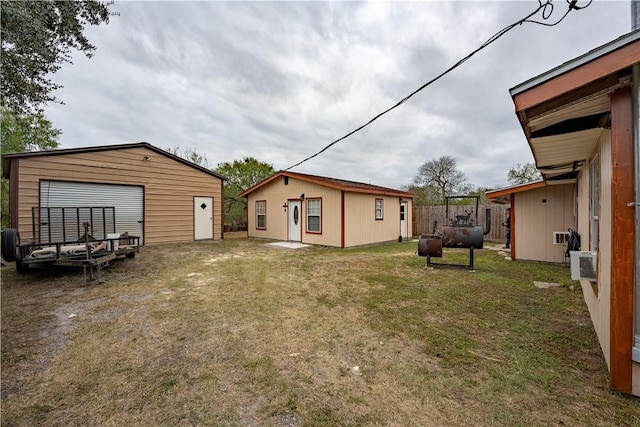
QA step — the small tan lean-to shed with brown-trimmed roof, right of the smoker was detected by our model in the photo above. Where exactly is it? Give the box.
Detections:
[486,181,576,263]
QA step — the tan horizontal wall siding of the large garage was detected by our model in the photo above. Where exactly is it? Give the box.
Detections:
[11,148,222,244]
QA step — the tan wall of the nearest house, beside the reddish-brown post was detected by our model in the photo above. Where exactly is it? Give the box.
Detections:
[578,132,612,366]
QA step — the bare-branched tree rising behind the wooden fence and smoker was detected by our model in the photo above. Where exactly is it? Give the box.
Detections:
[413,156,470,204]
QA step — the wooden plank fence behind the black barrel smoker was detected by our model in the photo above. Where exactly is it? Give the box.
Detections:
[413,204,509,240]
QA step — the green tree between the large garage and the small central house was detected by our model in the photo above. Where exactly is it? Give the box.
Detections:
[214,157,275,221]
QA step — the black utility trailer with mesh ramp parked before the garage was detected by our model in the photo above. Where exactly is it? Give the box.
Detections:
[1,206,140,282]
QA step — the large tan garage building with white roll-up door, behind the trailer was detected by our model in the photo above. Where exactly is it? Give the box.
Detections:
[2,142,225,244]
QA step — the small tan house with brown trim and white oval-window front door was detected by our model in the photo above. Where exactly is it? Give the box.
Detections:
[240,172,416,248]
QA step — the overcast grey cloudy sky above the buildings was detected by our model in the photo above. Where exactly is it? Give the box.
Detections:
[46,0,631,188]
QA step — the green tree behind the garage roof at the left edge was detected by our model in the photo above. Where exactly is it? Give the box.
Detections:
[0,108,61,227]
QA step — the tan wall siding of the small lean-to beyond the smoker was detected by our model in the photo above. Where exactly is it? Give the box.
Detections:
[514,185,575,263]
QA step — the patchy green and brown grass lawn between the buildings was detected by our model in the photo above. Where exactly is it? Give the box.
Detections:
[1,233,640,427]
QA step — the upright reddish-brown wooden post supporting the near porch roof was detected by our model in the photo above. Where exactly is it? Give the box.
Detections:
[610,87,635,394]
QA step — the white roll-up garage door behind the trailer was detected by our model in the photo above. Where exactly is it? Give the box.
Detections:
[40,181,144,244]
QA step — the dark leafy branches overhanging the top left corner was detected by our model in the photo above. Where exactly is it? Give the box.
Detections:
[0,0,113,114]
